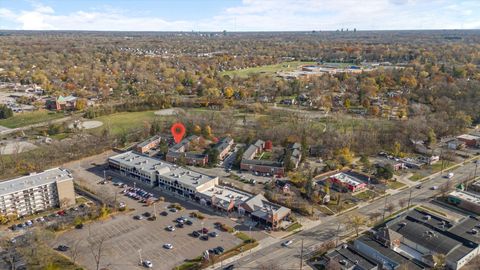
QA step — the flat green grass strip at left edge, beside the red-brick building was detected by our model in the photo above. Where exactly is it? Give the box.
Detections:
[0,111,65,128]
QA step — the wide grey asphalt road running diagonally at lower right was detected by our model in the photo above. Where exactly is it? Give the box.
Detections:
[222,161,480,269]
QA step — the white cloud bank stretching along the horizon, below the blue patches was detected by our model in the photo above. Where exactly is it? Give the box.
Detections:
[0,0,480,31]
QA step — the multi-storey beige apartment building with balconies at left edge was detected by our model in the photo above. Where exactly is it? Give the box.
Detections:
[0,168,75,216]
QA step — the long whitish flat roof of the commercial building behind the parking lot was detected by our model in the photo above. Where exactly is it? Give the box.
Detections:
[109,151,217,188]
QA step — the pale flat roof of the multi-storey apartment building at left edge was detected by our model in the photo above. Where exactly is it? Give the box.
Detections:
[0,168,73,195]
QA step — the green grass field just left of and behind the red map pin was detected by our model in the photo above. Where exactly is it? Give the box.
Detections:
[92,111,160,135]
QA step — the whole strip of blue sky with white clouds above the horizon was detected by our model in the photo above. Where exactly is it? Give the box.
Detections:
[0,0,480,31]
